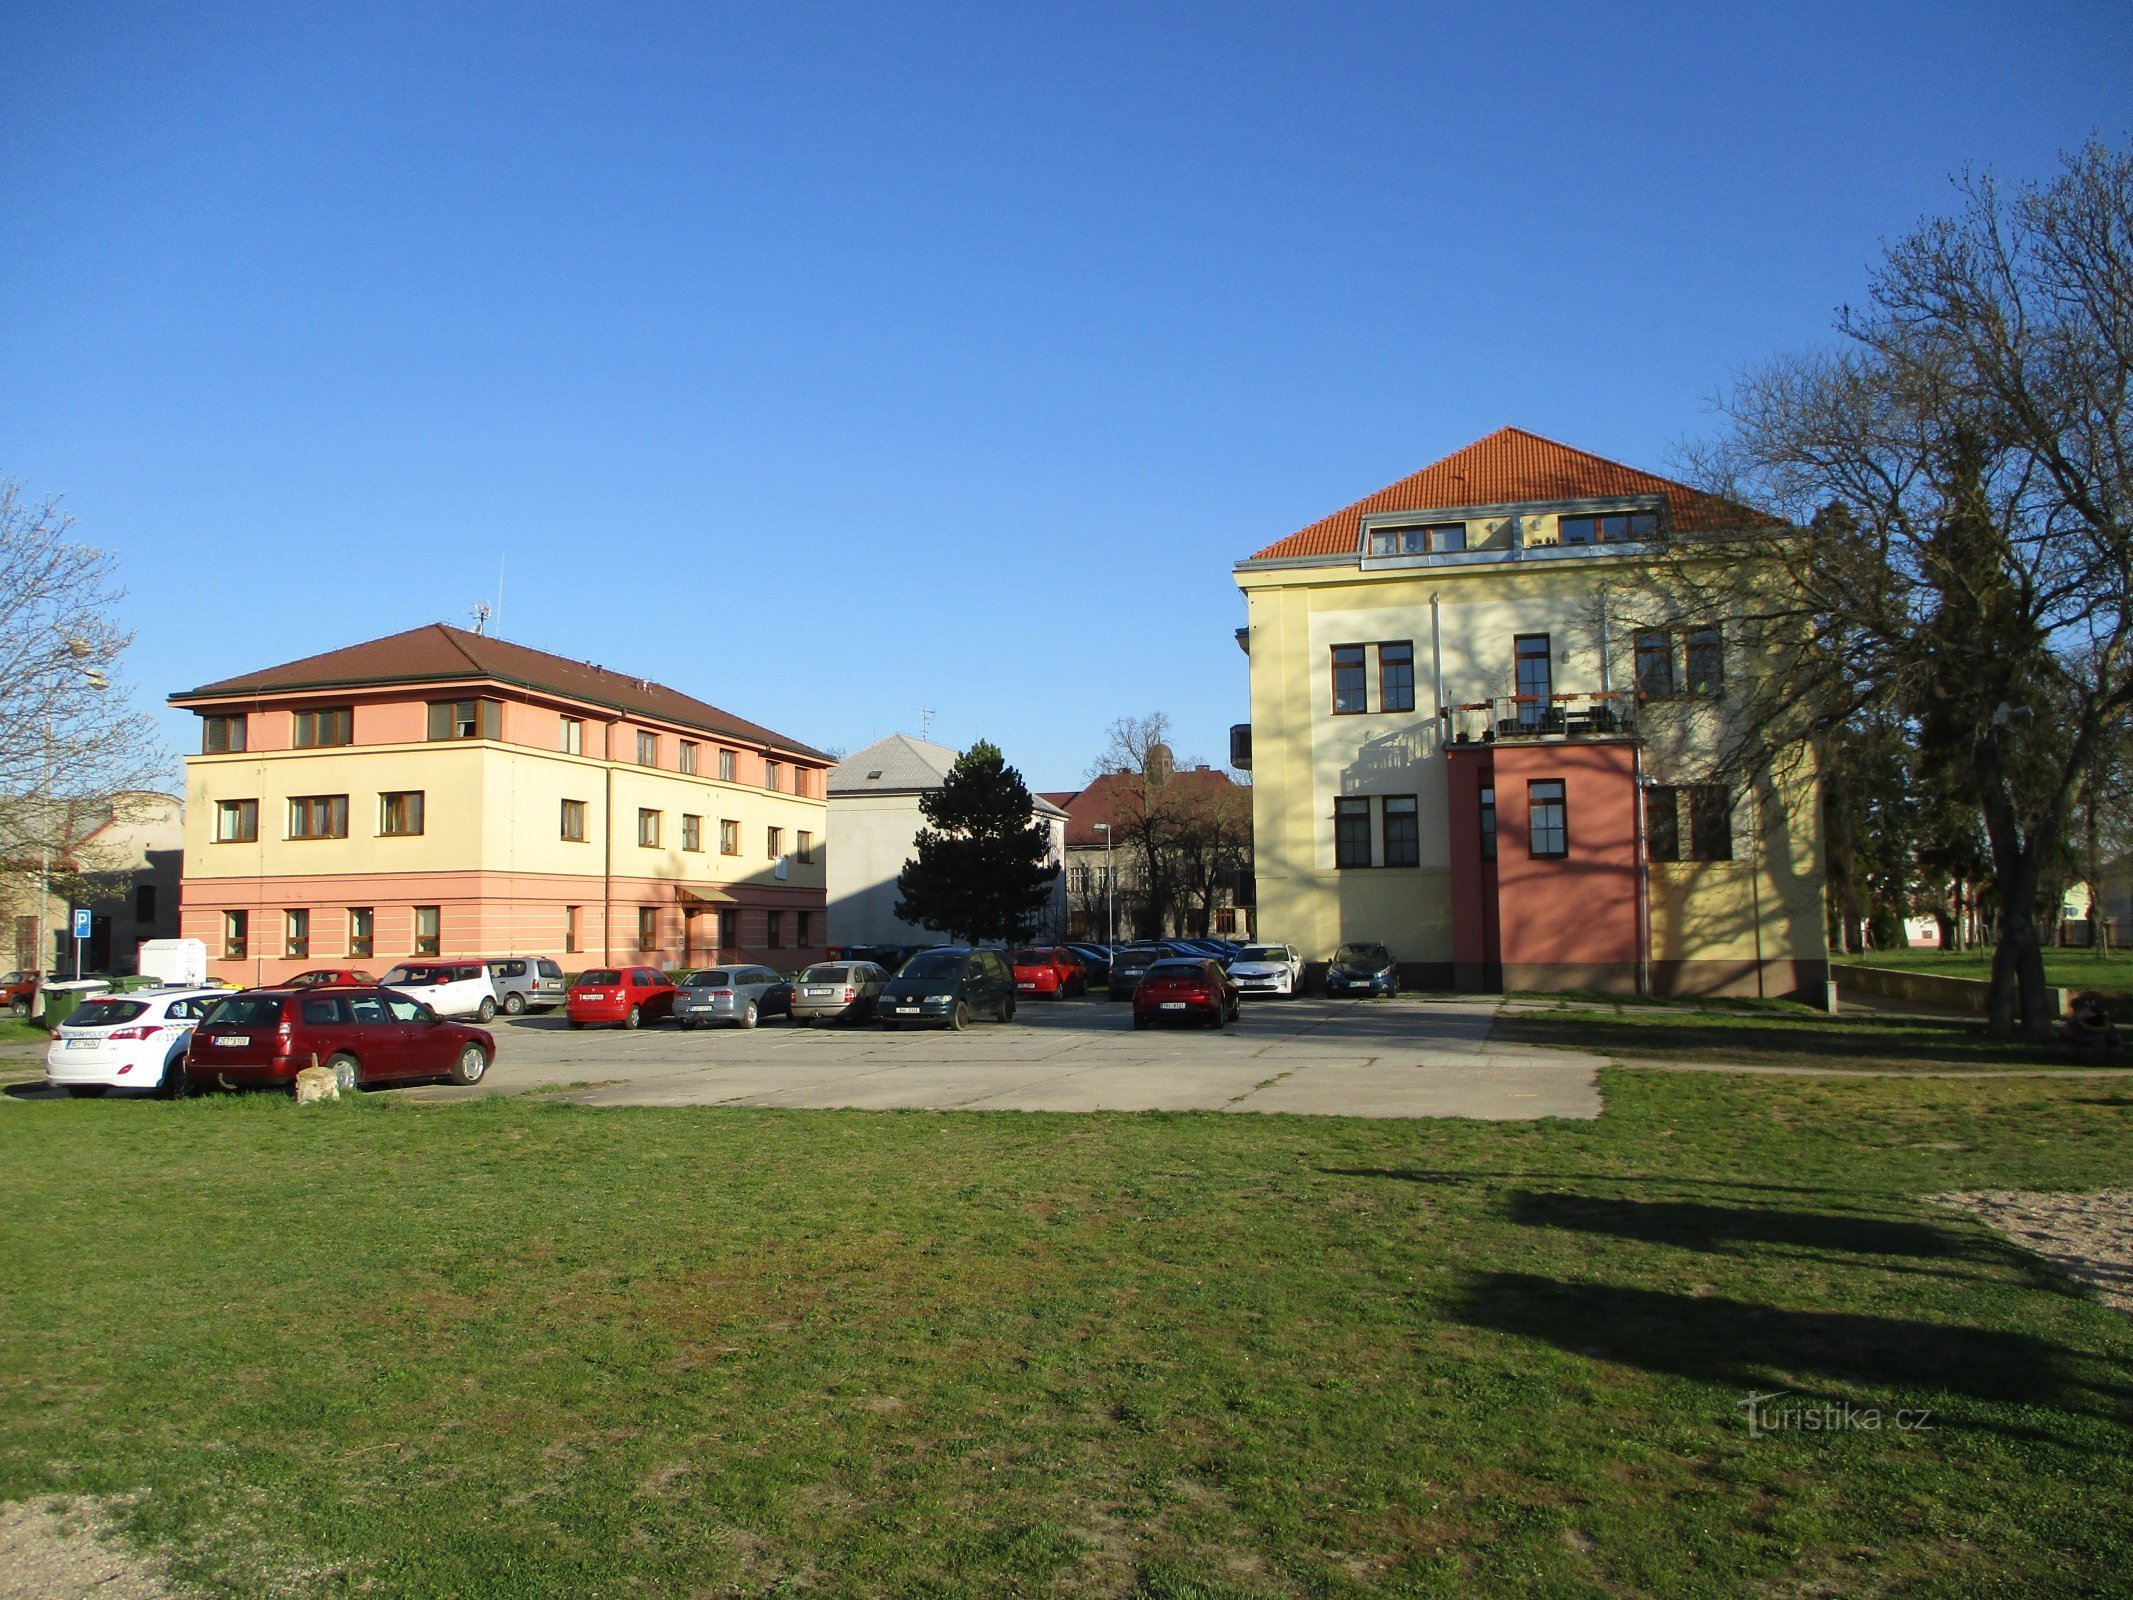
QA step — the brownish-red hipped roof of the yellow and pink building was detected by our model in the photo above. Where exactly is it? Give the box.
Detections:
[171,623,830,762]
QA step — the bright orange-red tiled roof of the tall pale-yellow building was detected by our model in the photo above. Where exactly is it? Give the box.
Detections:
[1252,429,1760,561]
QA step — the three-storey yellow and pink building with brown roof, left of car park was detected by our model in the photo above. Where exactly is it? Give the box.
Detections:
[171,623,832,983]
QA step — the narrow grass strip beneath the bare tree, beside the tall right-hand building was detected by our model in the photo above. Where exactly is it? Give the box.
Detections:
[1491,996,2086,1073]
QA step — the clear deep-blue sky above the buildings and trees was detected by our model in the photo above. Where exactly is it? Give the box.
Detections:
[0,0,2133,787]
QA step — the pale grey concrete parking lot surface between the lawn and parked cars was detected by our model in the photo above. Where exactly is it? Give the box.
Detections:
[392,998,1604,1120]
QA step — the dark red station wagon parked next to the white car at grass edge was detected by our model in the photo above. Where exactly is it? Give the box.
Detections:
[186,988,497,1092]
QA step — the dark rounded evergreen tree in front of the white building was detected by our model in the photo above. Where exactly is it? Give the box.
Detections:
[896,740,1060,943]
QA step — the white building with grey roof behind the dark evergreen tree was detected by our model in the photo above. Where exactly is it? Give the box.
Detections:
[825,734,1067,945]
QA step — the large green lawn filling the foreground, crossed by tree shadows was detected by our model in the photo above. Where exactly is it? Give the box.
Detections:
[0,1071,2133,1600]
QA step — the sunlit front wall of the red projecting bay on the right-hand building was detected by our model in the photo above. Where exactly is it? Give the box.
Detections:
[1493,740,1636,966]
